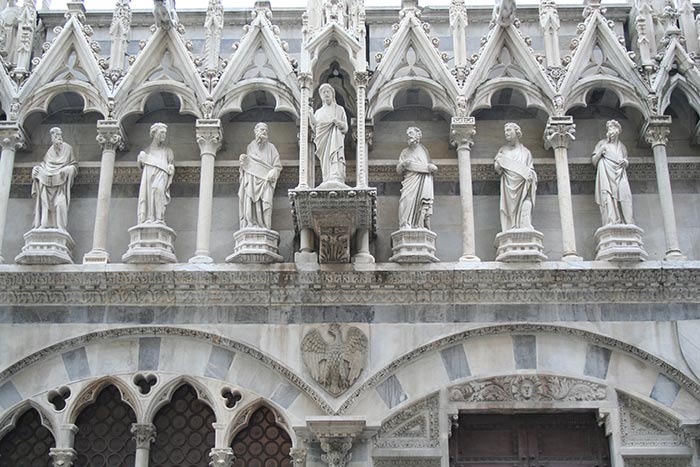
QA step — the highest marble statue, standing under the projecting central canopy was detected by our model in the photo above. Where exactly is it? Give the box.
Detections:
[309,83,348,185]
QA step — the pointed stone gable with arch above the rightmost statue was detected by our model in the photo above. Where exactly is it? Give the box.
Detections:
[559,10,651,117]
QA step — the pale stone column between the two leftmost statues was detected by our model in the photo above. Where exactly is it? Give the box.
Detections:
[83,120,124,264]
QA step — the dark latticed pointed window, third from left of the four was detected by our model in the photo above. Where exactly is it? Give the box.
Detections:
[148,385,216,467]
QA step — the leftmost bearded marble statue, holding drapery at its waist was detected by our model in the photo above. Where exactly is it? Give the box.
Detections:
[32,127,78,232]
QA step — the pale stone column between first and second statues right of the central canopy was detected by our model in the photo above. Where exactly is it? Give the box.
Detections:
[450,117,480,261]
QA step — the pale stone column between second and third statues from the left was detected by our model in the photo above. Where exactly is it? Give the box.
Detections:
[190,119,222,263]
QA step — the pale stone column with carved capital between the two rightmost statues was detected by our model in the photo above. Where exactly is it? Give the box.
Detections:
[544,116,583,261]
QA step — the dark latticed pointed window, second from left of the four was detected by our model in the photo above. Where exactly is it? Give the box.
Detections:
[73,385,136,467]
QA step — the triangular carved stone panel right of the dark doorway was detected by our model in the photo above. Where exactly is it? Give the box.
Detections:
[618,393,690,447]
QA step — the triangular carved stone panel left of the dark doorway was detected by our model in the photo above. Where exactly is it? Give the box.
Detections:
[374,394,440,449]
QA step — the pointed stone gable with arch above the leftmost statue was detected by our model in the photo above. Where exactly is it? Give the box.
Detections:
[18,16,111,121]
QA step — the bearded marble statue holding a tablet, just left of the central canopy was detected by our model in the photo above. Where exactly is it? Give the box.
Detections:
[238,123,282,230]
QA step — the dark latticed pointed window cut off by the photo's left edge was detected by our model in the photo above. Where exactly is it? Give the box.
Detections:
[0,409,56,467]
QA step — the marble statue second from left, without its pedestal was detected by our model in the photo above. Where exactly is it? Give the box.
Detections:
[137,123,175,224]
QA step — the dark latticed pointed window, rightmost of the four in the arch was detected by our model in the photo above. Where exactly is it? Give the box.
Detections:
[231,406,292,467]
